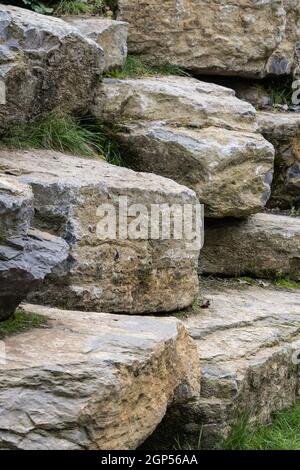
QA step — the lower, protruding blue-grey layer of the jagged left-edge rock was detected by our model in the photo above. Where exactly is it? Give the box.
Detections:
[0,230,69,321]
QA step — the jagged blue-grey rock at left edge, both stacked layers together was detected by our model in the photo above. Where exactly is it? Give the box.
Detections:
[0,175,68,321]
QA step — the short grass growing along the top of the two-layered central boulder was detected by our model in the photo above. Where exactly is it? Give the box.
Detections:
[104,54,190,79]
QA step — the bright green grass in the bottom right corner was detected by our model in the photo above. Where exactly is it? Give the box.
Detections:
[223,402,300,450]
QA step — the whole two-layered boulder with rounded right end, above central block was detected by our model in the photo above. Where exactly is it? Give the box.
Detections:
[92,77,274,217]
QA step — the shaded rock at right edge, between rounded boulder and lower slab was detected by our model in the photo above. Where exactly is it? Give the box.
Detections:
[199,213,300,280]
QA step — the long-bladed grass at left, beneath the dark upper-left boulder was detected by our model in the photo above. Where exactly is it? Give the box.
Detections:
[1,114,121,164]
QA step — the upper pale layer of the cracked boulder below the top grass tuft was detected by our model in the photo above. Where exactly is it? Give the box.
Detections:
[92,76,257,132]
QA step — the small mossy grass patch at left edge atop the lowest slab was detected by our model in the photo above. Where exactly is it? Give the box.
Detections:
[0,309,48,340]
